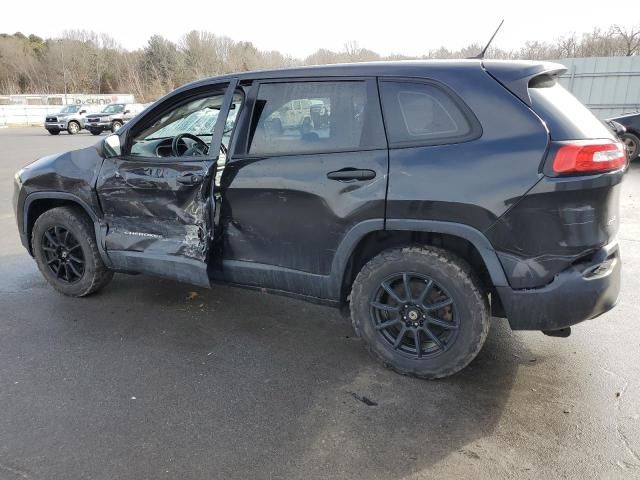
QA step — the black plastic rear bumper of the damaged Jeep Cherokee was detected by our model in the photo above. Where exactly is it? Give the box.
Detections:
[496,242,622,330]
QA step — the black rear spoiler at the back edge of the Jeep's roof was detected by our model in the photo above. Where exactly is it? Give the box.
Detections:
[482,60,567,106]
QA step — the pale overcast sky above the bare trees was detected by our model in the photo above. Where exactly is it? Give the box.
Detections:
[0,0,640,57]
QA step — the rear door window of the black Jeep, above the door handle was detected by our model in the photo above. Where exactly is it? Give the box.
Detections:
[249,80,385,155]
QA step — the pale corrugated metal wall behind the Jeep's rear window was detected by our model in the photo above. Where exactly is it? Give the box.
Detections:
[557,57,640,119]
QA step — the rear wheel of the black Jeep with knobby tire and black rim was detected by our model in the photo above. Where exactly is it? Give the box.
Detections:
[350,247,490,379]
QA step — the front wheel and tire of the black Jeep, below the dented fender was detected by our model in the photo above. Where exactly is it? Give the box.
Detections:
[31,207,113,297]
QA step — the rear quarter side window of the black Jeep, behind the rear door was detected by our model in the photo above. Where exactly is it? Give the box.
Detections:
[380,81,479,146]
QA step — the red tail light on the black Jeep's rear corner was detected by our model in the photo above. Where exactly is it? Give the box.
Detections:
[553,140,627,174]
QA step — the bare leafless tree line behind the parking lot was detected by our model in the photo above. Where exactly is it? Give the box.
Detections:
[0,25,640,102]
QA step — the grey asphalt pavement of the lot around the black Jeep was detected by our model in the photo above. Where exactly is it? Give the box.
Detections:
[0,128,640,480]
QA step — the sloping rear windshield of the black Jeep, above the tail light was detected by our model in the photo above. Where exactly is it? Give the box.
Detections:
[529,79,611,140]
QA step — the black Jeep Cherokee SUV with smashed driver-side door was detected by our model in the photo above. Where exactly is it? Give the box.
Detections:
[14,60,627,378]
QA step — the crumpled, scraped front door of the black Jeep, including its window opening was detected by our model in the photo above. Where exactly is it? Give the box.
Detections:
[96,81,242,286]
